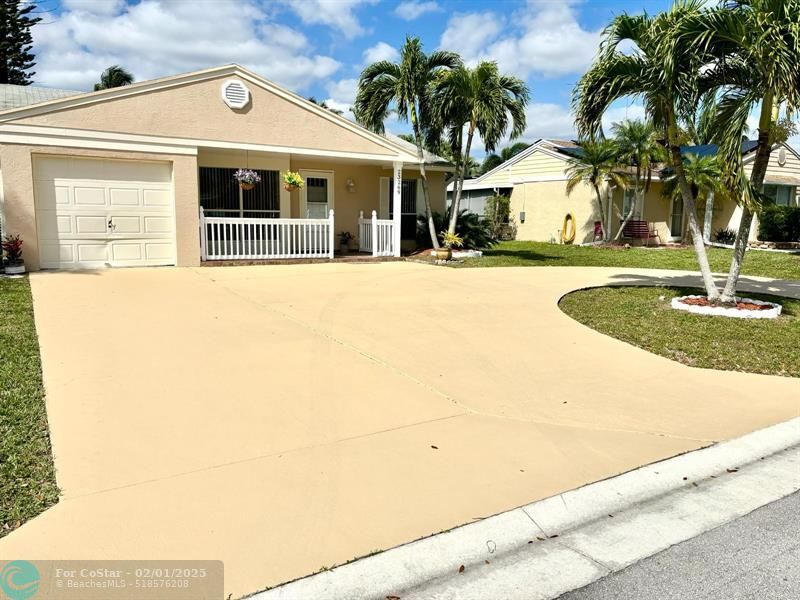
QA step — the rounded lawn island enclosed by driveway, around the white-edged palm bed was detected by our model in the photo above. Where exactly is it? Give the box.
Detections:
[559,287,800,377]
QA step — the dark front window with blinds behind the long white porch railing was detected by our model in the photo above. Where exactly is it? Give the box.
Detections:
[198,167,280,218]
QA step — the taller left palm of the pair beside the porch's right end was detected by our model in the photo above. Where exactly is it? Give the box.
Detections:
[353,37,461,248]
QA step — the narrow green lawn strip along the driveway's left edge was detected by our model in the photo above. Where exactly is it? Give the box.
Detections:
[0,277,58,537]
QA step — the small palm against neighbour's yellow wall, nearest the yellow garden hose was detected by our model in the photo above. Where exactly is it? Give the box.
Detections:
[564,139,627,240]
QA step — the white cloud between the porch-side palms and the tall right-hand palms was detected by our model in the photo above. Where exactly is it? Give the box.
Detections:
[440,0,600,79]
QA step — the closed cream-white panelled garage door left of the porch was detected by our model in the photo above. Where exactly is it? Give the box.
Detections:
[34,157,175,269]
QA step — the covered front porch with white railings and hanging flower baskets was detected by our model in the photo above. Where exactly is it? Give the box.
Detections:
[192,149,445,261]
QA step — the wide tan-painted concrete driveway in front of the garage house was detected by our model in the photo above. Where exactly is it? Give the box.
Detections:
[0,263,800,596]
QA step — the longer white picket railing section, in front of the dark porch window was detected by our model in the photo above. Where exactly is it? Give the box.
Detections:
[200,207,334,260]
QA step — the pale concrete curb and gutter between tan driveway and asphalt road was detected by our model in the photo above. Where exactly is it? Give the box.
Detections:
[254,417,800,600]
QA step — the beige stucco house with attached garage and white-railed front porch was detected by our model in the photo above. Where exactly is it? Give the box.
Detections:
[0,65,451,269]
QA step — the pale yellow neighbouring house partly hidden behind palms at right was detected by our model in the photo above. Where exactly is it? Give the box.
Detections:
[448,139,800,243]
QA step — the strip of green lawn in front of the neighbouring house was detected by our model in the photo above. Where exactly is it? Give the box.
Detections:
[459,242,800,279]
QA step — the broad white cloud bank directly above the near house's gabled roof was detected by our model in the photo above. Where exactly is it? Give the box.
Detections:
[33,0,340,90]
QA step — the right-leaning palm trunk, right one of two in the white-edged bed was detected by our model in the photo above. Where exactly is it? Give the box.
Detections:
[720,93,773,304]
